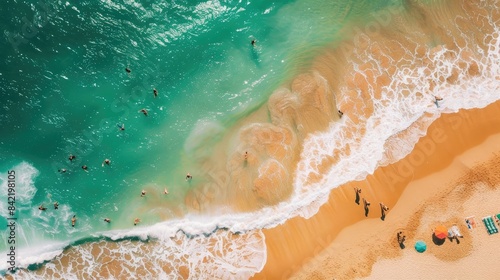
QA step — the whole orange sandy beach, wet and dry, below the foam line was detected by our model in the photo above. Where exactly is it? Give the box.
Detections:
[254,99,500,279]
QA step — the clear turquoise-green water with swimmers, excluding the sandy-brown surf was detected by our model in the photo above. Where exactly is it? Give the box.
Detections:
[0,0,408,272]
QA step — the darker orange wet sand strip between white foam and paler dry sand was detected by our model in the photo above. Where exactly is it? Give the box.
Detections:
[253,101,500,279]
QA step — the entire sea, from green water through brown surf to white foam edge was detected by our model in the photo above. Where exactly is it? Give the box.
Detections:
[0,0,500,279]
